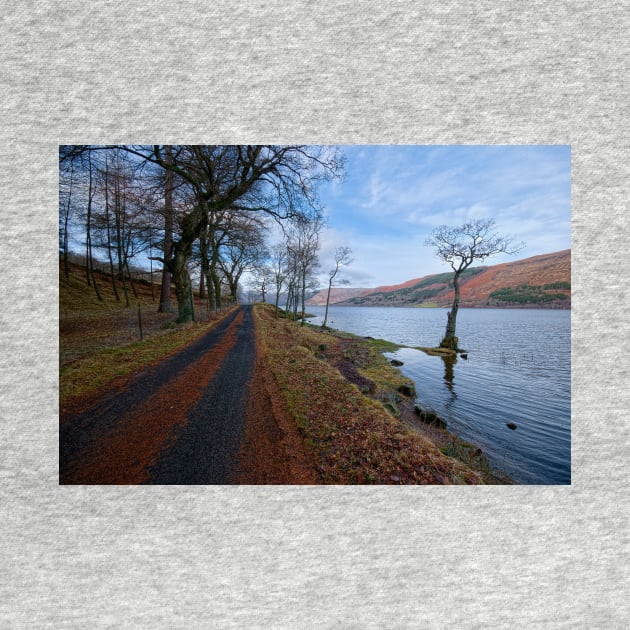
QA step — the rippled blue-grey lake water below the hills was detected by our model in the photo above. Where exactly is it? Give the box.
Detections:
[308,306,571,484]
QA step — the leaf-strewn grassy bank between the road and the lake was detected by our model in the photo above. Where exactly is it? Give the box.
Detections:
[255,305,506,484]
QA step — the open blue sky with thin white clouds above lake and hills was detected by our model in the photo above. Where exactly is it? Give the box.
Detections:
[320,145,571,287]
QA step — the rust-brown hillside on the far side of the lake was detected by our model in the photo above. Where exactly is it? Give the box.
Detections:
[326,249,571,308]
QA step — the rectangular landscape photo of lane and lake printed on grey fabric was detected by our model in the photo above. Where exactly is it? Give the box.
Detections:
[59,144,571,485]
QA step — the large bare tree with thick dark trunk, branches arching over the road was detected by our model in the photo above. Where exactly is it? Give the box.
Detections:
[125,145,343,322]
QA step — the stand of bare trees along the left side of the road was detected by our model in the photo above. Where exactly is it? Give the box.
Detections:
[59,145,344,322]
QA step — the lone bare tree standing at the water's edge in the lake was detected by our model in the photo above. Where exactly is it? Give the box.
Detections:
[426,219,524,351]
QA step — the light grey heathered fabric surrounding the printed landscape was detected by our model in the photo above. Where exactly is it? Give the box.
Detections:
[0,0,630,629]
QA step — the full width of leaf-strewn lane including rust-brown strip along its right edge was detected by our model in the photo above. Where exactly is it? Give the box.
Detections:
[59,307,317,484]
